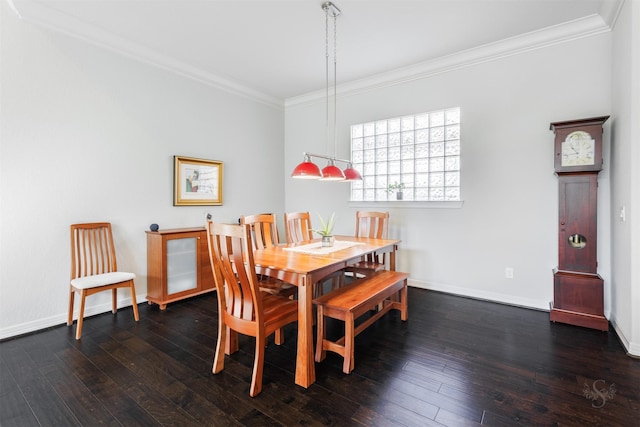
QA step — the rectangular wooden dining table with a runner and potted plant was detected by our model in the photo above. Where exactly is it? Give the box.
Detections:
[254,236,400,388]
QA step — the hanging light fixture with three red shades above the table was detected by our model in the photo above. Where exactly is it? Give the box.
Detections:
[291,1,362,181]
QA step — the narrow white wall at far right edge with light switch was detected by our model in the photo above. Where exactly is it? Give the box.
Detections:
[610,1,640,355]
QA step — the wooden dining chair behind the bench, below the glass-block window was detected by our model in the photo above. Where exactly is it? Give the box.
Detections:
[345,211,389,277]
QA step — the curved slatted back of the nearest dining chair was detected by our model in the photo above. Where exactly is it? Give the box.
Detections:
[207,221,262,323]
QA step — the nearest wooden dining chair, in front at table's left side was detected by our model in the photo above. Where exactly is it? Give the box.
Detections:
[207,221,298,397]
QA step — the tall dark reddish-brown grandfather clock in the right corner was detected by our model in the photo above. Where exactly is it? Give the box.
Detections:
[550,116,609,331]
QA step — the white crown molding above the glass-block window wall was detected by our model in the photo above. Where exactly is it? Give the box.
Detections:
[285,13,617,108]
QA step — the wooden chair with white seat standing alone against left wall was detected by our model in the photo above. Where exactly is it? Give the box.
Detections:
[67,222,140,340]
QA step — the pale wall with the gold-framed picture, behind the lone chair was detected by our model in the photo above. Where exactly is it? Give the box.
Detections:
[0,1,284,338]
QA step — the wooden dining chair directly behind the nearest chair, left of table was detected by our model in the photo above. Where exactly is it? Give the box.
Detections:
[240,213,298,297]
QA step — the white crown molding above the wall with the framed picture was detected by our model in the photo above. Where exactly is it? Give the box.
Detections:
[7,0,283,109]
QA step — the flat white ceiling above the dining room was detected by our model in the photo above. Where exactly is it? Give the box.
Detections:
[7,0,623,105]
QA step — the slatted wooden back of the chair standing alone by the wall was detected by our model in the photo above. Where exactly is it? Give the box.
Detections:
[71,222,118,279]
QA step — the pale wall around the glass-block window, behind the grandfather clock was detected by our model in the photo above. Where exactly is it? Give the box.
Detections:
[285,33,611,314]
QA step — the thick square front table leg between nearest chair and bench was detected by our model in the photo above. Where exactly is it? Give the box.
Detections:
[296,275,316,388]
